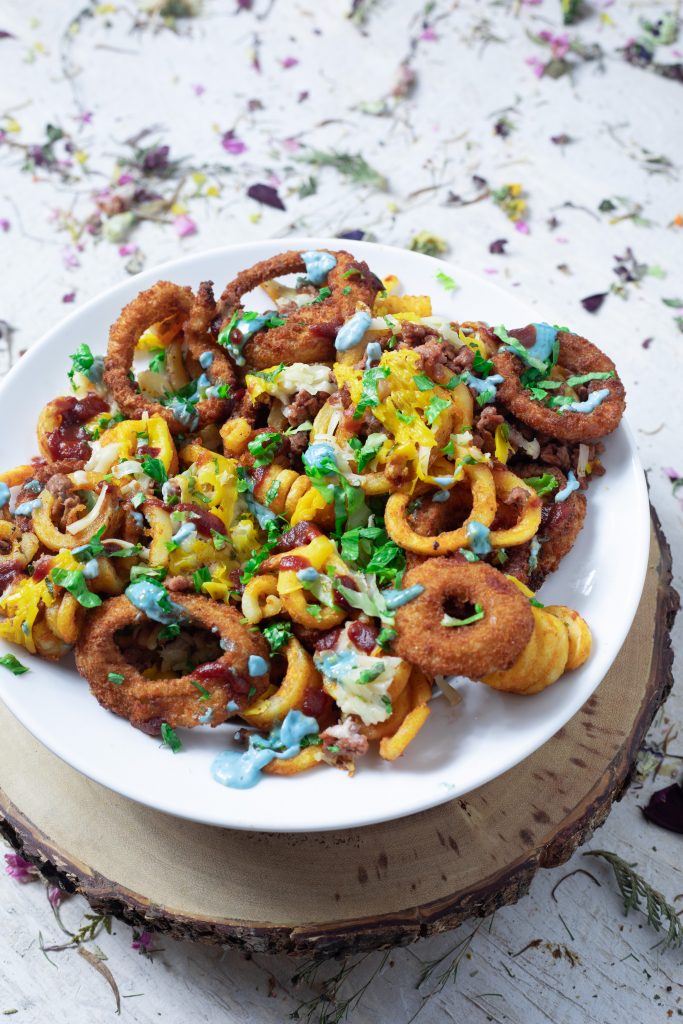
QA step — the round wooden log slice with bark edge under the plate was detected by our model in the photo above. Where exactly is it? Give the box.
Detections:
[0,514,678,955]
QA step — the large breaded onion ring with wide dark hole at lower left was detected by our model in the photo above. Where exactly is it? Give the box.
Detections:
[76,594,268,731]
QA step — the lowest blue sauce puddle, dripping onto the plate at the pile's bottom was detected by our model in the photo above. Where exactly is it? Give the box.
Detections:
[211,711,318,790]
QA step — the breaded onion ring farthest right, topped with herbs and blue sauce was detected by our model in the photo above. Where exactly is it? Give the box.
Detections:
[494,328,626,441]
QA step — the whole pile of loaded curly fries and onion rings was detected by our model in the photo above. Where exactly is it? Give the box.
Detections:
[0,248,625,788]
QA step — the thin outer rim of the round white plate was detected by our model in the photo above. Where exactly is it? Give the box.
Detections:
[0,236,650,834]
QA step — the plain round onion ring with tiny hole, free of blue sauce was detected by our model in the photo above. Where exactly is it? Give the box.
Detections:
[393,557,533,679]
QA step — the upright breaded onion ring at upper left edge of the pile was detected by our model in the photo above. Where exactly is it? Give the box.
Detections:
[104,281,236,434]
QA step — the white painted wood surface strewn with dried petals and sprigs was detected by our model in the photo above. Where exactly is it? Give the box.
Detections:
[0,0,683,1024]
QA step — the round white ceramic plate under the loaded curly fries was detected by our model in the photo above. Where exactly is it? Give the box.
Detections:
[0,239,649,831]
